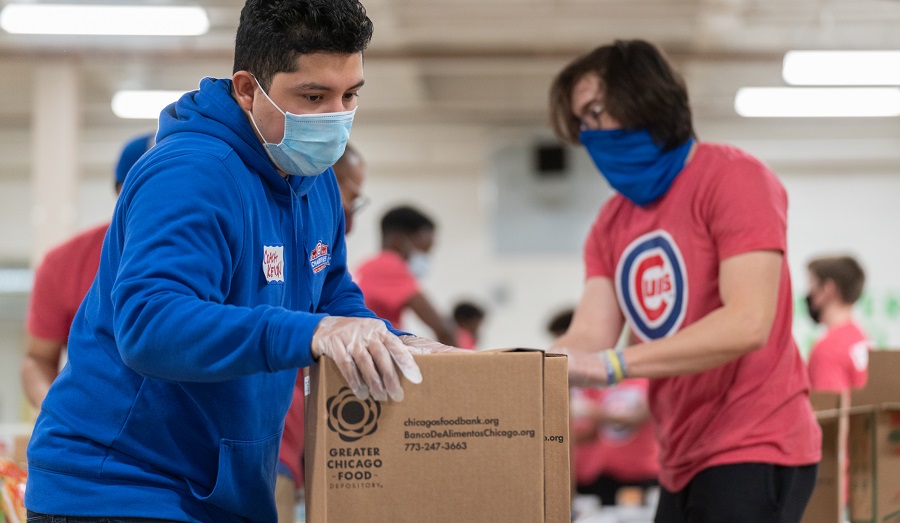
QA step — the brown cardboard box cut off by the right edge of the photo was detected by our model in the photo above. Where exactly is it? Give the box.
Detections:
[849,351,900,523]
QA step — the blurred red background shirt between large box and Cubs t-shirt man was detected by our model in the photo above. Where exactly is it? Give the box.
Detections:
[572,379,659,485]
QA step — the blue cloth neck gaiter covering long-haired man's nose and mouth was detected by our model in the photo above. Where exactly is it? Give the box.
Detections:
[579,129,694,206]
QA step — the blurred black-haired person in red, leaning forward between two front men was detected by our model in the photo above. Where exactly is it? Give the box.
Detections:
[354,206,457,347]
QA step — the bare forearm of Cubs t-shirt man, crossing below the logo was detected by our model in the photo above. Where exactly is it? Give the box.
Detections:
[623,307,771,378]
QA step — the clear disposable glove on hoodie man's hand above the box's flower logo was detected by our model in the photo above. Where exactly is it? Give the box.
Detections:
[310,316,422,401]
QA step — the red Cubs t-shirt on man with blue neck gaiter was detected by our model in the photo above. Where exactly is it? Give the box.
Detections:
[585,143,821,492]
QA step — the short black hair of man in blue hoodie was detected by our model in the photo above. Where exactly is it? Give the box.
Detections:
[233,0,373,90]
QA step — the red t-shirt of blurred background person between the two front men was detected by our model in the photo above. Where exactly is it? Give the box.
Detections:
[353,251,419,329]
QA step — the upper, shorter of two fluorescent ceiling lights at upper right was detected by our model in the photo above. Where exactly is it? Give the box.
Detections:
[782,51,900,85]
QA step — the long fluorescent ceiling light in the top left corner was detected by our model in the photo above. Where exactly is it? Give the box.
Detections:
[0,4,209,36]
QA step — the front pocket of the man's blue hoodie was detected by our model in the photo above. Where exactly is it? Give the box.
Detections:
[189,433,281,521]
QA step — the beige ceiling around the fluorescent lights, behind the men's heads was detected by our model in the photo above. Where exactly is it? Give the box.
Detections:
[0,0,900,177]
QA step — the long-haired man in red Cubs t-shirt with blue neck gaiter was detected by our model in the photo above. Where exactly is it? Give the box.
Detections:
[551,40,821,523]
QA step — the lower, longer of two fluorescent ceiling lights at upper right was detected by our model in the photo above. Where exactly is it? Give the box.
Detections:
[734,87,900,118]
